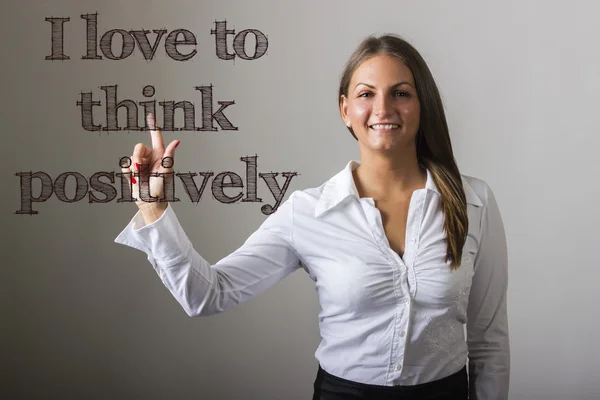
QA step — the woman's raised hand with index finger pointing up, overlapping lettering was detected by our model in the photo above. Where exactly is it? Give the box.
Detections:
[121,114,180,211]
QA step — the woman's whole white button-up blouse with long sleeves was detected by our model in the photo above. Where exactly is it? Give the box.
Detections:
[115,161,510,400]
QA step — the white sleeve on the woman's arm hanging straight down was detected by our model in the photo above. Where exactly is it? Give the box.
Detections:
[467,185,510,400]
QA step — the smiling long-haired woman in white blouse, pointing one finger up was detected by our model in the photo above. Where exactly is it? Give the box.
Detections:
[116,35,510,400]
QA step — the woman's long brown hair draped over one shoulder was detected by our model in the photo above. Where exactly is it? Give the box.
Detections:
[338,34,469,270]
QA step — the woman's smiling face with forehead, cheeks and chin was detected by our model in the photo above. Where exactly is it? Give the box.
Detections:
[340,55,421,152]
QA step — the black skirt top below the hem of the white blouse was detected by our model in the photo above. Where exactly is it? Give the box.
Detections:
[313,365,469,400]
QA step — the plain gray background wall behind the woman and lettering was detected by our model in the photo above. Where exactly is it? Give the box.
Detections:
[0,0,600,400]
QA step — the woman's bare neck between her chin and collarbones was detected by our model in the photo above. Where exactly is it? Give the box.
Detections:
[353,150,427,201]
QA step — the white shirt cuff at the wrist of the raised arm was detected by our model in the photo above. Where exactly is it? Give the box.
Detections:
[115,203,192,267]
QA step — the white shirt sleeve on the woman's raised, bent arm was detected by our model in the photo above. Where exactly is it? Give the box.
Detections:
[115,194,300,316]
